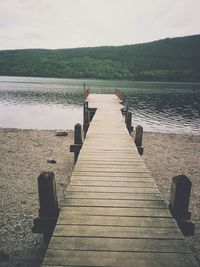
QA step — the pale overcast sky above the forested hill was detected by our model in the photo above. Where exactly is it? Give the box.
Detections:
[0,0,200,50]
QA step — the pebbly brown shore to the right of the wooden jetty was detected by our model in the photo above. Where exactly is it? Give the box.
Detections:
[143,133,200,266]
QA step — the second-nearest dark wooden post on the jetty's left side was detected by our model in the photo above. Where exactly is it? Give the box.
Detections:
[70,123,83,164]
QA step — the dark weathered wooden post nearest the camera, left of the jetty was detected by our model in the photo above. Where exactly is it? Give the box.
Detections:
[32,172,59,243]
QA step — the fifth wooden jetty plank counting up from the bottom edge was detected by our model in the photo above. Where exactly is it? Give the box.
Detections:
[60,206,172,218]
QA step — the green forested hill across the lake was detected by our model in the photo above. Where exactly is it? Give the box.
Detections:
[0,35,200,82]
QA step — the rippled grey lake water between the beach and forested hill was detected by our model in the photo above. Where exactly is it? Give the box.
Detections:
[0,76,200,134]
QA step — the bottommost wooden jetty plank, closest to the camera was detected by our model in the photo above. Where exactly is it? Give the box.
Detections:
[43,249,199,267]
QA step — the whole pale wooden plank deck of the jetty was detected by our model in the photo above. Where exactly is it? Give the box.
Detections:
[43,94,198,267]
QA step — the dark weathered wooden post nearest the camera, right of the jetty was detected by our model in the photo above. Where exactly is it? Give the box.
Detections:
[169,175,195,236]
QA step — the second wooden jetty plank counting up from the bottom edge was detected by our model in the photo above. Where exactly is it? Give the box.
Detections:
[49,239,189,253]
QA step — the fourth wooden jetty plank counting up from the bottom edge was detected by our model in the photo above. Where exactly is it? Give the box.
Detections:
[57,213,177,227]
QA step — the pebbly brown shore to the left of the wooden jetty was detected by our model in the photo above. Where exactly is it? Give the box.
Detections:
[0,129,73,267]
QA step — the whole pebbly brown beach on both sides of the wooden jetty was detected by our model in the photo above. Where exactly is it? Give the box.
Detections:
[0,129,200,267]
